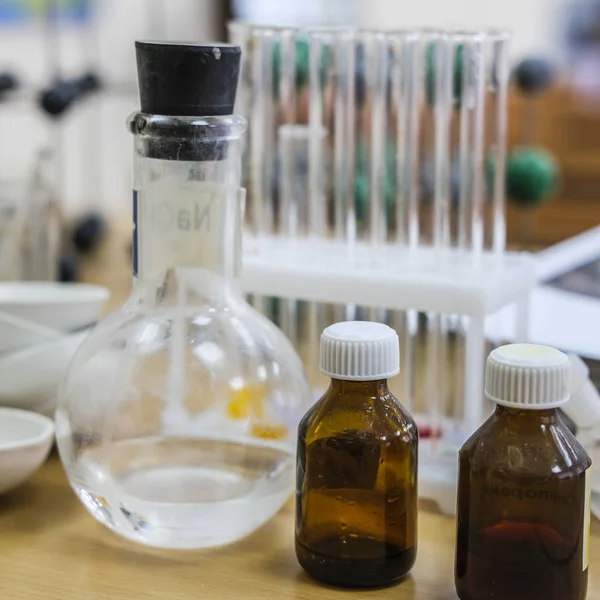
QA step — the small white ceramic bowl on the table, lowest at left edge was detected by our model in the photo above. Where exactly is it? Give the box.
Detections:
[0,408,54,494]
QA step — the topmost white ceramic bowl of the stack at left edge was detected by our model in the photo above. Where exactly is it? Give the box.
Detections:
[0,281,109,354]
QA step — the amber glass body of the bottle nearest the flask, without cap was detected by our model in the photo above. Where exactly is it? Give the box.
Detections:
[296,379,417,586]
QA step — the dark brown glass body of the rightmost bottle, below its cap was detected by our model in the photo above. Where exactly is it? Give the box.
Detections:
[455,345,591,600]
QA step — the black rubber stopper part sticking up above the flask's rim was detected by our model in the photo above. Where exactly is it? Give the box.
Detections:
[135,42,241,117]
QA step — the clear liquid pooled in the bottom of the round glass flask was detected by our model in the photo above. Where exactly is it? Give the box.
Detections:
[72,437,295,548]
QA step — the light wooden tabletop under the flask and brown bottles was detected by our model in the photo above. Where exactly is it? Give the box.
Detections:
[0,226,600,600]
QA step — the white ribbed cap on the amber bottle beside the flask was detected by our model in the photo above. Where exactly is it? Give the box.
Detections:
[319,321,400,381]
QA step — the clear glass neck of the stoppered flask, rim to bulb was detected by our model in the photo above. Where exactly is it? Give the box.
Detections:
[130,114,244,296]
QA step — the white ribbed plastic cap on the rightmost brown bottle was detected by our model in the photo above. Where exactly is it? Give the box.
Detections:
[485,344,570,409]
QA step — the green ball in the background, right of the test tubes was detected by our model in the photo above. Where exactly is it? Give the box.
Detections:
[506,148,559,206]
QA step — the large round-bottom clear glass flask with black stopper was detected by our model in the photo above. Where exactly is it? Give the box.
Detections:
[56,43,310,548]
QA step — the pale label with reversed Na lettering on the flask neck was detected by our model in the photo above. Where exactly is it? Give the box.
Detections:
[134,181,245,277]
